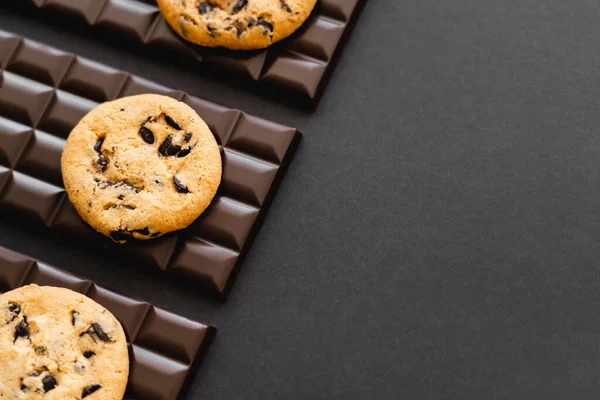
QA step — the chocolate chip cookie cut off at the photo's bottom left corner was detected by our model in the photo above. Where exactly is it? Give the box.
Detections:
[0,285,129,400]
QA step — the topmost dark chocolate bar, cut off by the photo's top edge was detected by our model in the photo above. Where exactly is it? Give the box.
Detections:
[8,0,365,105]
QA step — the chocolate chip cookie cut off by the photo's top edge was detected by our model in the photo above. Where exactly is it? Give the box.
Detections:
[158,0,317,50]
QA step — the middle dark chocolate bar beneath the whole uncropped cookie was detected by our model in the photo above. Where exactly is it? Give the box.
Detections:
[0,31,301,294]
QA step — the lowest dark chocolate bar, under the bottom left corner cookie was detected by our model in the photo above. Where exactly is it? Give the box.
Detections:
[0,247,216,400]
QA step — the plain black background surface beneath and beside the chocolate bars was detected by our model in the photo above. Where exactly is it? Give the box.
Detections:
[0,0,600,399]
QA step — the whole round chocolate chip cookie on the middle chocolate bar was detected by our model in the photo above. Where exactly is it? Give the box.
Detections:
[61,94,222,243]
